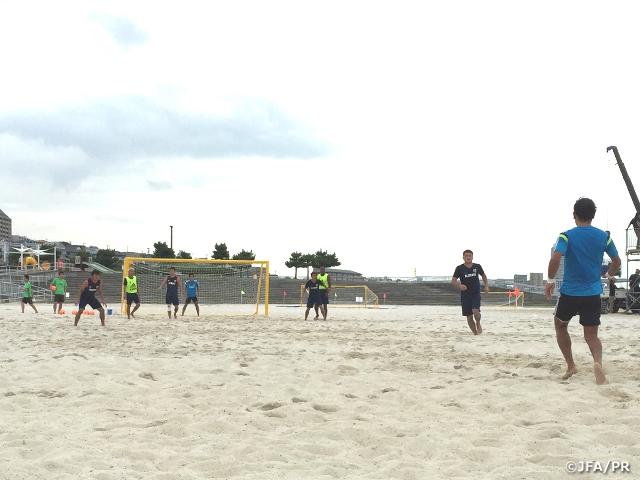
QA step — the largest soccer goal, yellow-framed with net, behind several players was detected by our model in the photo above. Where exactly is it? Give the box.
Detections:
[122,257,269,317]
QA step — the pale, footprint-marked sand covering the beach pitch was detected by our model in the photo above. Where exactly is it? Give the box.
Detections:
[0,304,640,479]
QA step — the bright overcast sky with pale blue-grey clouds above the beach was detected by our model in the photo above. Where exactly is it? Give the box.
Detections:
[0,1,640,278]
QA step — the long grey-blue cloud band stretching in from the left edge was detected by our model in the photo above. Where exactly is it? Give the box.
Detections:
[0,95,333,163]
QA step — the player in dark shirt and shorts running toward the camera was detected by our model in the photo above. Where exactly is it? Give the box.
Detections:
[451,250,489,335]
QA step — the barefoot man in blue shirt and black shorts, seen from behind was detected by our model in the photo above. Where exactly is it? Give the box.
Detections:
[544,197,622,385]
